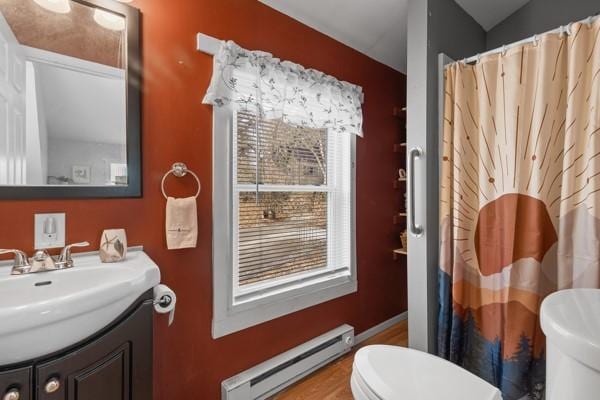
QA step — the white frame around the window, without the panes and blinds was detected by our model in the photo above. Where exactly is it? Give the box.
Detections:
[212,107,358,338]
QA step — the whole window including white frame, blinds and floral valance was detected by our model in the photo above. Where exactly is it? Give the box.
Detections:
[205,40,360,337]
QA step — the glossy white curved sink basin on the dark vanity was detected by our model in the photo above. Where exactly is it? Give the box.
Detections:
[0,250,160,366]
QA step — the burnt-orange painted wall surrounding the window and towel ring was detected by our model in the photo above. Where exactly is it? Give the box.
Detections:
[0,0,406,400]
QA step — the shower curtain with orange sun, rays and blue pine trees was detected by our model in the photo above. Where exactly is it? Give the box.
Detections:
[438,19,600,400]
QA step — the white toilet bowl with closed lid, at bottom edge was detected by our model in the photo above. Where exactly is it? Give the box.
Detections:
[350,345,502,400]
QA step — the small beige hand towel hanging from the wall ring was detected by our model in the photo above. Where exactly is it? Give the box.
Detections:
[166,197,198,250]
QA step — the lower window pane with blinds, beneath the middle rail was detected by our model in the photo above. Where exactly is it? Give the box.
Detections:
[238,192,327,285]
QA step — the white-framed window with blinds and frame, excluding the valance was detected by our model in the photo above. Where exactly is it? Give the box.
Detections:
[213,109,357,337]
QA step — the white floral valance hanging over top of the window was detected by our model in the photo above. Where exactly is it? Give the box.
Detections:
[203,41,363,136]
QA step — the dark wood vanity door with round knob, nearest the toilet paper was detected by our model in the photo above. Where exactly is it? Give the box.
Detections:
[36,303,152,400]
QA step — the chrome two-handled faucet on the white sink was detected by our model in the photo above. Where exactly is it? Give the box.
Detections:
[0,242,90,275]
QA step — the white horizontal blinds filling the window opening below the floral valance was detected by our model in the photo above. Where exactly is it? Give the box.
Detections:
[234,111,351,288]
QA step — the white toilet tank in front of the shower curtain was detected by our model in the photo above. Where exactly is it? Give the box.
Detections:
[540,289,600,400]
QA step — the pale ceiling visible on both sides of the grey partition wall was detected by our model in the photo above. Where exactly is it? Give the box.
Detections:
[260,0,529,73]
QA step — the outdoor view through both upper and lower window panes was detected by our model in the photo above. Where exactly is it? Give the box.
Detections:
[236,112,330,287]
